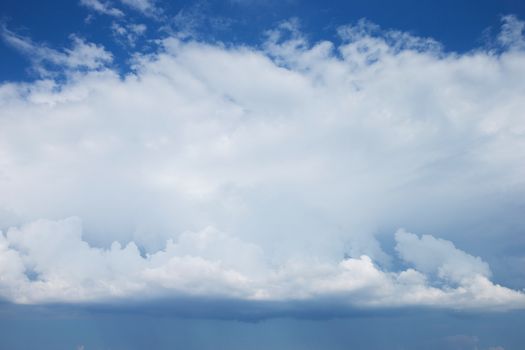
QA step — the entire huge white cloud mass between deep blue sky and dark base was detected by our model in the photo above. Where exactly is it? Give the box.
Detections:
[0,15,525,310]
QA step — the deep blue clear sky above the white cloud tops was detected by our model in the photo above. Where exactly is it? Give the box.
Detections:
[0,0,525,80]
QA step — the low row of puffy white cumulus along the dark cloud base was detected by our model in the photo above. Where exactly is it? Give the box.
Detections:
[0,218,525,309]
